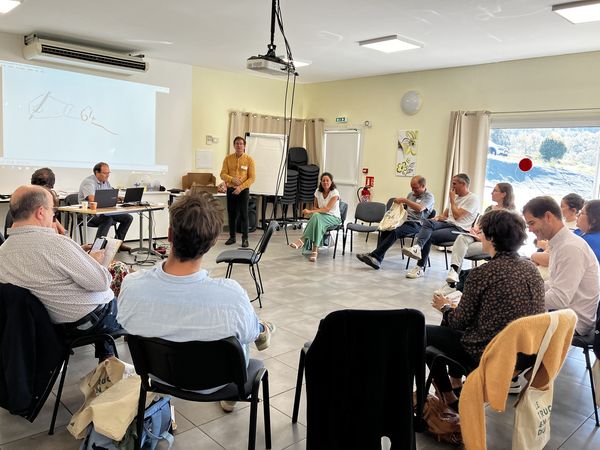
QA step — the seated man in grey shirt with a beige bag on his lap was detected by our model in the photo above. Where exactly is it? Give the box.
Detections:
[356,175,434,269]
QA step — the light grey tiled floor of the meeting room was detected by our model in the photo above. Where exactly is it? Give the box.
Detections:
[0,229,600,450]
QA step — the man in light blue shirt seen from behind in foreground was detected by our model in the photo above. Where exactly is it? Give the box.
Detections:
[118,192,275,412]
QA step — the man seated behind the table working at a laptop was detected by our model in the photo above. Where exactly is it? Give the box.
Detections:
[78,162,133,252]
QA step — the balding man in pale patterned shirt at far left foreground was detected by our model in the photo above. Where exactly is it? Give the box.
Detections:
[0,185,120,360]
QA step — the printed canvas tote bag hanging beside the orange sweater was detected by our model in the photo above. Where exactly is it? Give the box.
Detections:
[512,314,558,450]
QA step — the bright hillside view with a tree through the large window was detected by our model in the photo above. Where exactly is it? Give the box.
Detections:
[484,127,600,210]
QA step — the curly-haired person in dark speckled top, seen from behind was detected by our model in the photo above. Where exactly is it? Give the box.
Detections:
[427,210,544,411]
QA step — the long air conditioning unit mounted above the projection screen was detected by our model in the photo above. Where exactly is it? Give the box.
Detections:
[23,34,148,75]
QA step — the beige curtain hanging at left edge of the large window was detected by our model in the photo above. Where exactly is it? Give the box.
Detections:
[443,111,490,209]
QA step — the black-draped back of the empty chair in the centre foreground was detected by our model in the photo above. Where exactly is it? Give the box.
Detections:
[305,309,425,449]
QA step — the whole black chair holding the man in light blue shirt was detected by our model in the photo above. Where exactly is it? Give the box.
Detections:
[127,336,271,450]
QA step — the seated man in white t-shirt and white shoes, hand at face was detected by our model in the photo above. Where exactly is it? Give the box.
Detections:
[402,173,479,278]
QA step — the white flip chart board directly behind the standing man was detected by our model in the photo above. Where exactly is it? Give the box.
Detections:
[246,133,287,195]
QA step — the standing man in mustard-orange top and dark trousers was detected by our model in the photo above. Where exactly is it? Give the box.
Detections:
[221,136,256,247]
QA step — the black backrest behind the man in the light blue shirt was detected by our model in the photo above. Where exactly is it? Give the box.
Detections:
[127,335,248,396]
